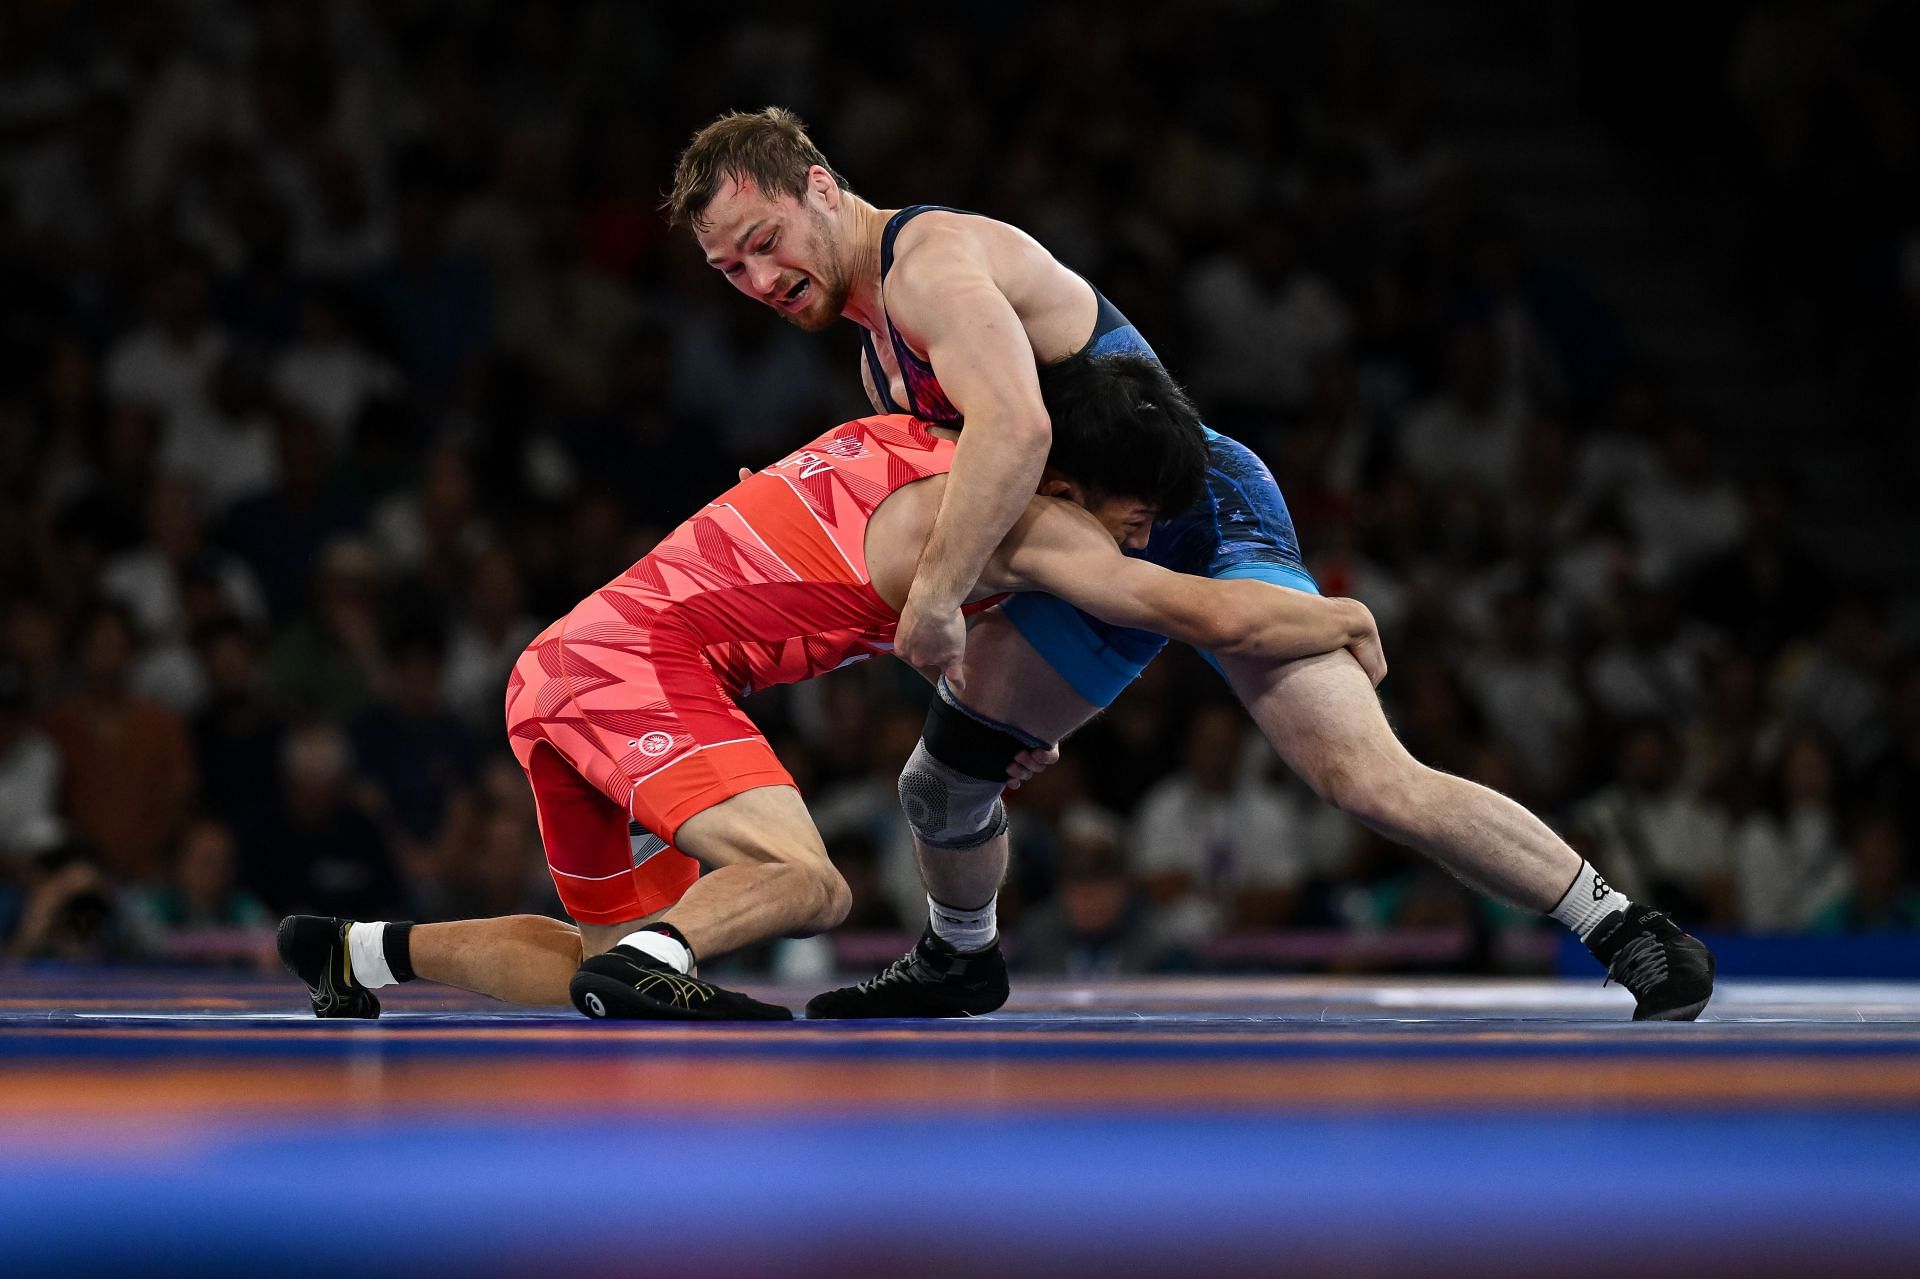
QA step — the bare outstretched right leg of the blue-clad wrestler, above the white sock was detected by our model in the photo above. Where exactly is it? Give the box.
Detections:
[1221,651,1580,914]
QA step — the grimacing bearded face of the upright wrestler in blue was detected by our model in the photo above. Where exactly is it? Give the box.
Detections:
[693,165,851,332]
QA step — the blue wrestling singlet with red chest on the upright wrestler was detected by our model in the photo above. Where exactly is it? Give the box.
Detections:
[860,204,1319,707]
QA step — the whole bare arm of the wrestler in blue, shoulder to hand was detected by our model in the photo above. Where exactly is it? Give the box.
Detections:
[887,229,1052,678]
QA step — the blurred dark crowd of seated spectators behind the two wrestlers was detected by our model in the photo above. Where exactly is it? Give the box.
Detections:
[0,0,1920,972]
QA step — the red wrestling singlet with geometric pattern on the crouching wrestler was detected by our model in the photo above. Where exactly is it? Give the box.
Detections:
[507,417,967,924]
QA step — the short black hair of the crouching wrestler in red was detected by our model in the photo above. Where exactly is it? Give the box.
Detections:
[1041,351,1208,515]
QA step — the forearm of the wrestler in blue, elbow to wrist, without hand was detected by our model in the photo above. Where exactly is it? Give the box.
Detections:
[912,412,1048,609]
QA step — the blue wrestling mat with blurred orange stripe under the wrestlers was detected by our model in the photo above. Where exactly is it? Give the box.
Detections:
[0,972,1920,1277]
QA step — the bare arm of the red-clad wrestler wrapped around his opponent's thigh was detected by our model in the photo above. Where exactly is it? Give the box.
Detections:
[981,497,1386,684]
